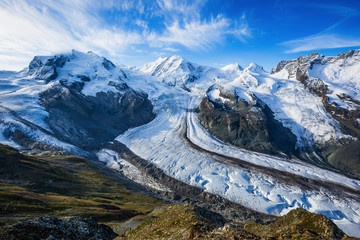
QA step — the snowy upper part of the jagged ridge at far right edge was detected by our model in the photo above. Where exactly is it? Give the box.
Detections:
[272,50,360,110]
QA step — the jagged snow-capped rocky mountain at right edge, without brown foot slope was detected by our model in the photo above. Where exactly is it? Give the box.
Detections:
[272,50,360,138]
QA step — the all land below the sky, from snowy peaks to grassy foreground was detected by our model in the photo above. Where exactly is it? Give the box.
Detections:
[0,50,360,239]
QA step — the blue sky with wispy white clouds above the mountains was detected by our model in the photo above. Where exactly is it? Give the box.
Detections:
[0,0,360,71]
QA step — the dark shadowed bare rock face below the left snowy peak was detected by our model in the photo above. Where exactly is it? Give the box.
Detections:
[40,83,155,149]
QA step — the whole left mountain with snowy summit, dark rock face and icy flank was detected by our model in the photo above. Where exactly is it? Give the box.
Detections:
[0,50,154,154]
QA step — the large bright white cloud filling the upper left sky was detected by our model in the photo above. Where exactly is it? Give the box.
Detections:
[0,0,144,69]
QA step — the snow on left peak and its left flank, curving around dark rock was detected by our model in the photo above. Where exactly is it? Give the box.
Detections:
[0,50,140,153]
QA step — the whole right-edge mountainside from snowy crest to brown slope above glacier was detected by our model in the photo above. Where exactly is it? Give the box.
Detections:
[272,50,360,176]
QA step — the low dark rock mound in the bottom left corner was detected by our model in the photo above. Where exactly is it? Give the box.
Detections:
[0,217,118,240]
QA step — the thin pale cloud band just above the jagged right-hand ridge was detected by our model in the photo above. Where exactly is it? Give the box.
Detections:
[281,34,360,53]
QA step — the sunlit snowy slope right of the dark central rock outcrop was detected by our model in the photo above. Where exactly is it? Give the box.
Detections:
[214,61,347,148]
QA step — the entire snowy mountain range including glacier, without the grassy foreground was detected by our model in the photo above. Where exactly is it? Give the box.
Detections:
[0,51,360,236]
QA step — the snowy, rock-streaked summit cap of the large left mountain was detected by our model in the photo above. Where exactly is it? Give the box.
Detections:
[28,50,131,96]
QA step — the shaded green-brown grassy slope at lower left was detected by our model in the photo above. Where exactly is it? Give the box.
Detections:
[0,142,164,229]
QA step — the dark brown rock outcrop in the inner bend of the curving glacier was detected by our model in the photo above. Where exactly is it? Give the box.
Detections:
[198,86,297,155]
